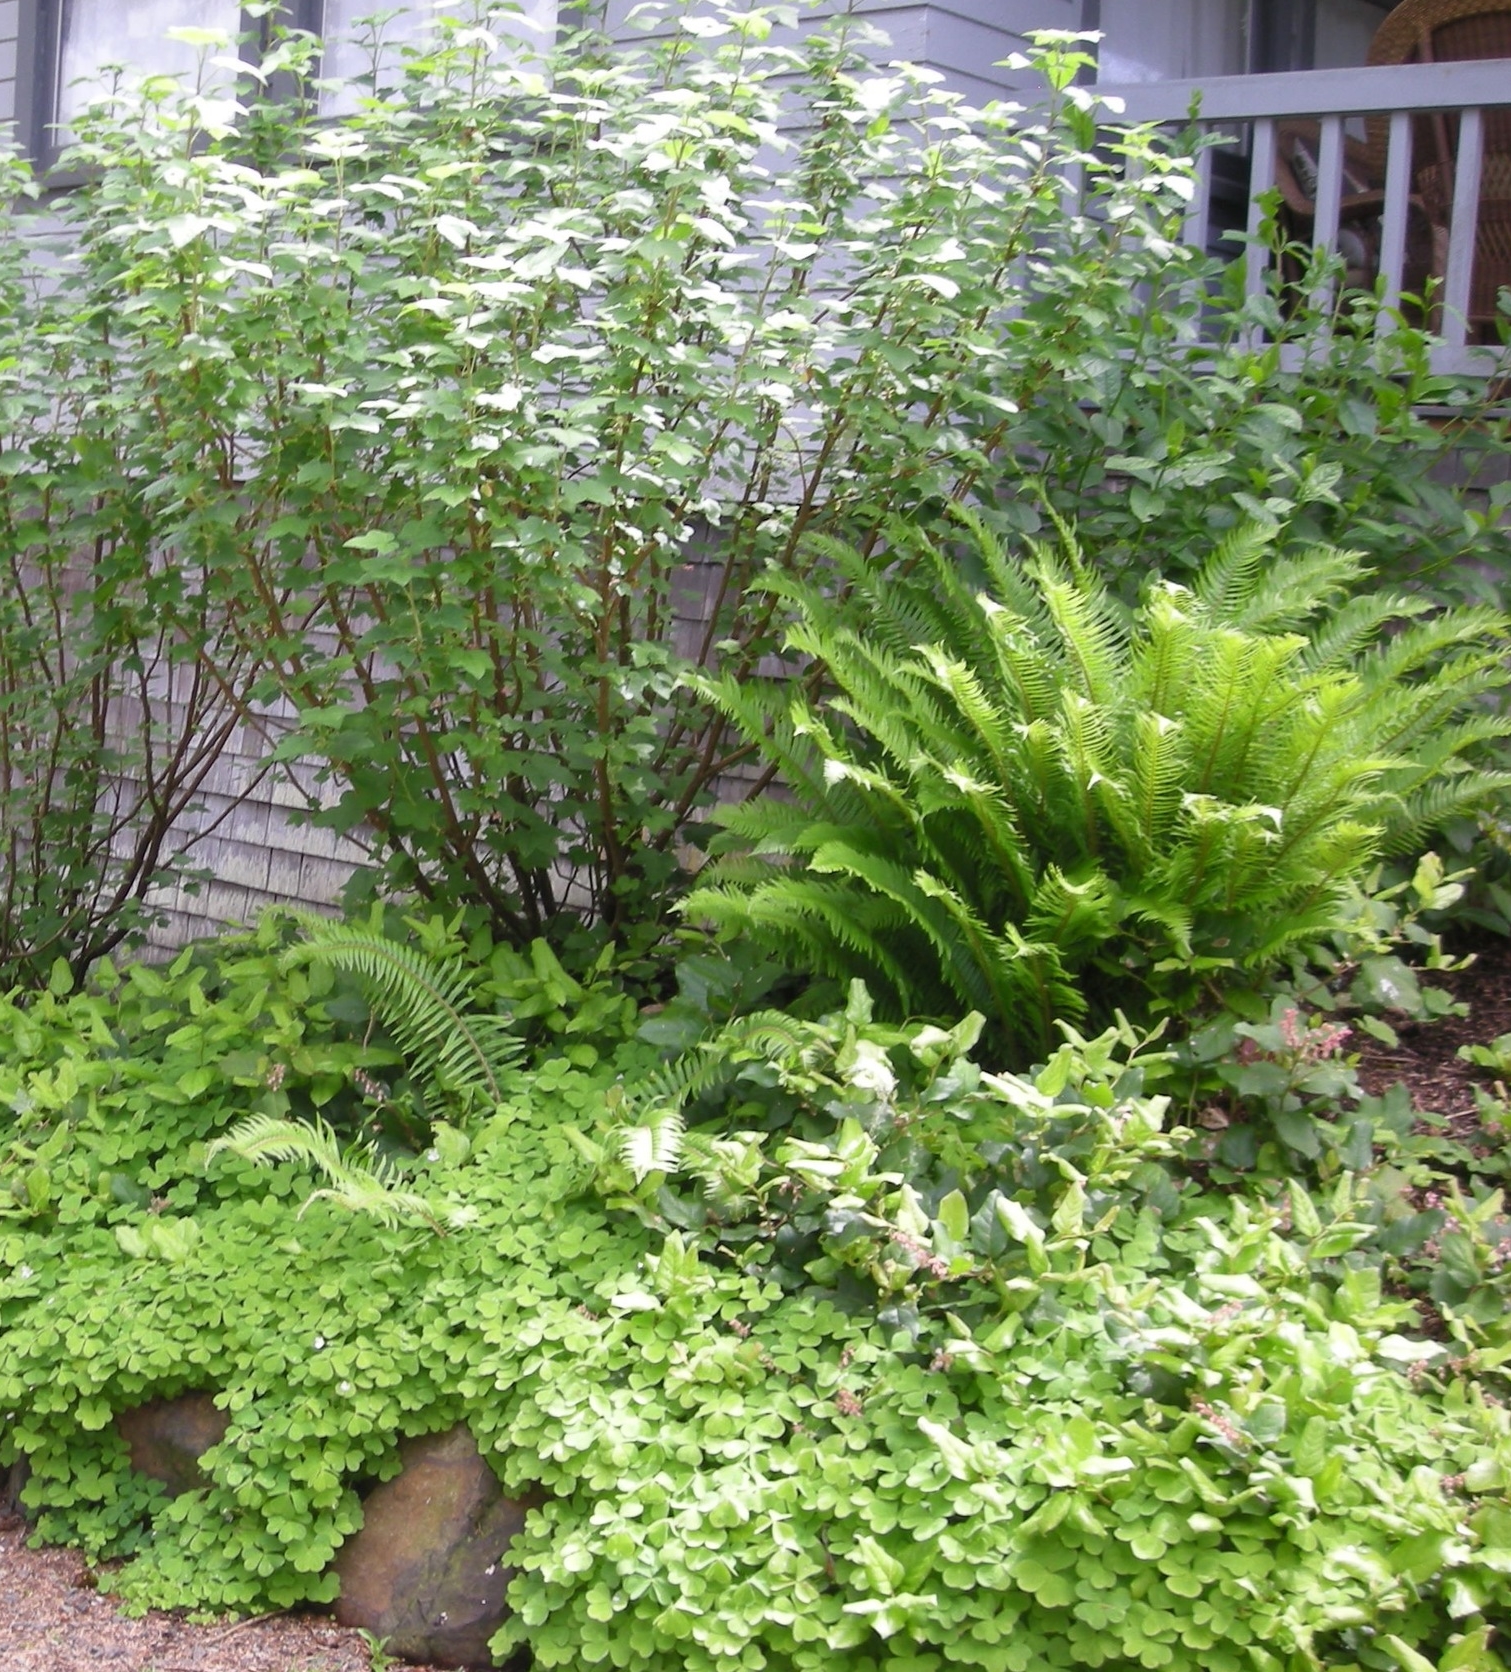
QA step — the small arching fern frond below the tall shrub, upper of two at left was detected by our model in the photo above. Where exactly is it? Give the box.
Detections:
[284,915,521,1104]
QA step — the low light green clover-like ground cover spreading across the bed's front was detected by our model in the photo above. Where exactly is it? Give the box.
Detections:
[0,926,1511,1672]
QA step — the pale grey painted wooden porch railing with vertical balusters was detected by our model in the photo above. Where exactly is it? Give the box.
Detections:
[1096,59,1511,375]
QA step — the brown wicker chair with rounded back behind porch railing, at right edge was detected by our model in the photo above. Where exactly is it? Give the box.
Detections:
[1369,0,1511,341]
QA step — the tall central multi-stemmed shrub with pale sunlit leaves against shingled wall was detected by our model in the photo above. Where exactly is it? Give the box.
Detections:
[0,0,1193,961]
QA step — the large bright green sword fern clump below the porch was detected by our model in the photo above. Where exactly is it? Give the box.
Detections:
[687,518,1511,1058]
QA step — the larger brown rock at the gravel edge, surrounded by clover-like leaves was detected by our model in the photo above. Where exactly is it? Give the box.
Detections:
[336,1425,530,1667]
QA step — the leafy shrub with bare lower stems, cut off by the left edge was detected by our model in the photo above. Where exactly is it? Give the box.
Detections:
[0,140,262,986]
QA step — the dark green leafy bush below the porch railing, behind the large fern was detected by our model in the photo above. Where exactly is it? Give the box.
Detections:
[1016,274,1511,605]
